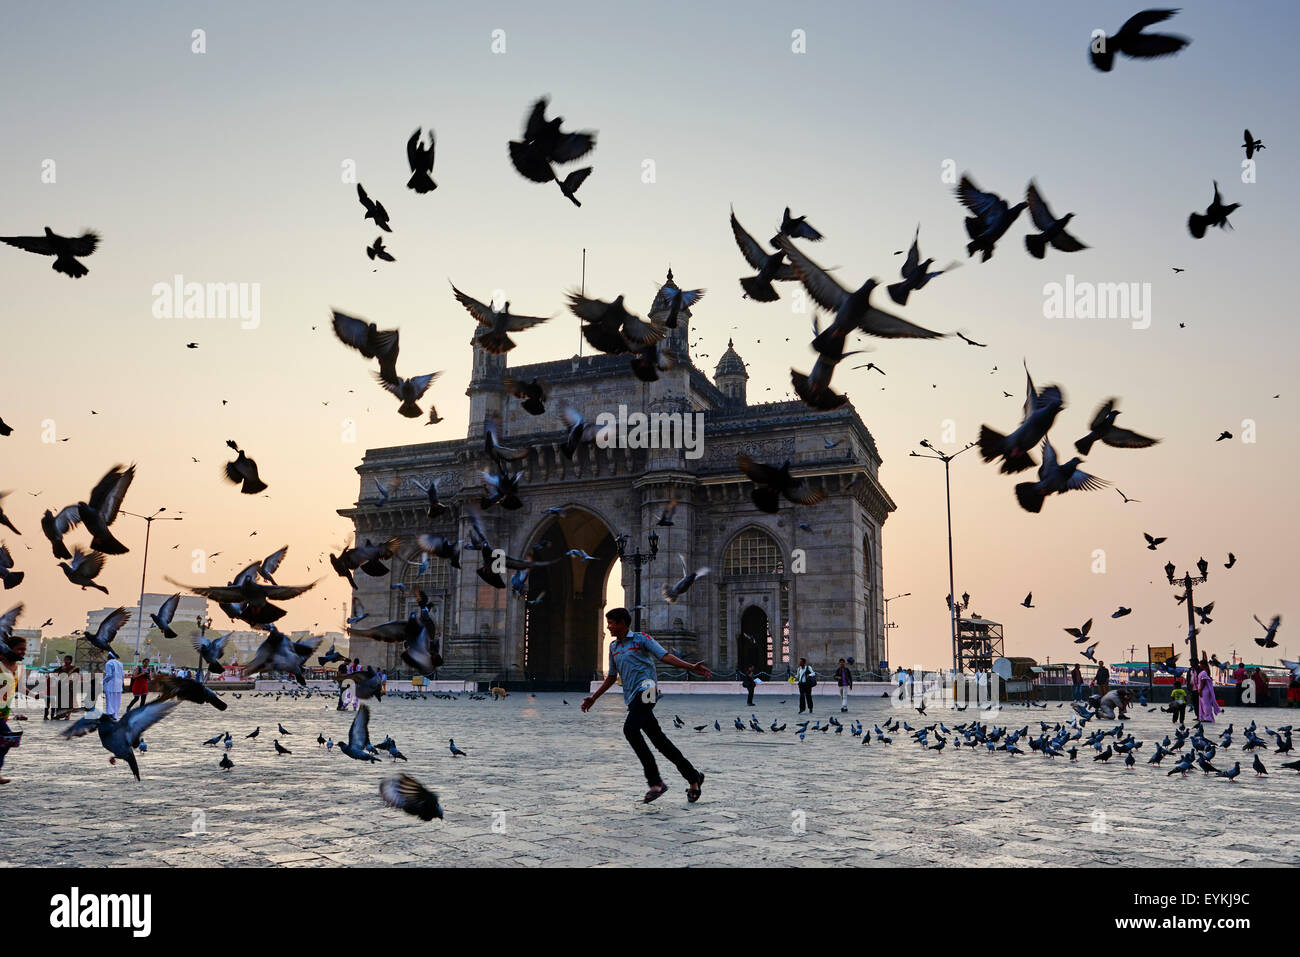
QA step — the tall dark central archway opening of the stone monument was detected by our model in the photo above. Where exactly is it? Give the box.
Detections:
[521,507,618,690]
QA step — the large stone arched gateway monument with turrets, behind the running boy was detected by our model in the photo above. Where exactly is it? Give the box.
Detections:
[339,270,896,689]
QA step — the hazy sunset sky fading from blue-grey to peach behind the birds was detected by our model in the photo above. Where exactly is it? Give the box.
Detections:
[0,0,1300,666]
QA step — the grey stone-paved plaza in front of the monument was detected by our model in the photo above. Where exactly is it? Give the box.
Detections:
[0,688,1300,867]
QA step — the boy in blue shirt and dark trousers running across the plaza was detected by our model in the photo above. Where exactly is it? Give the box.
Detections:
[582,609,714,804]
